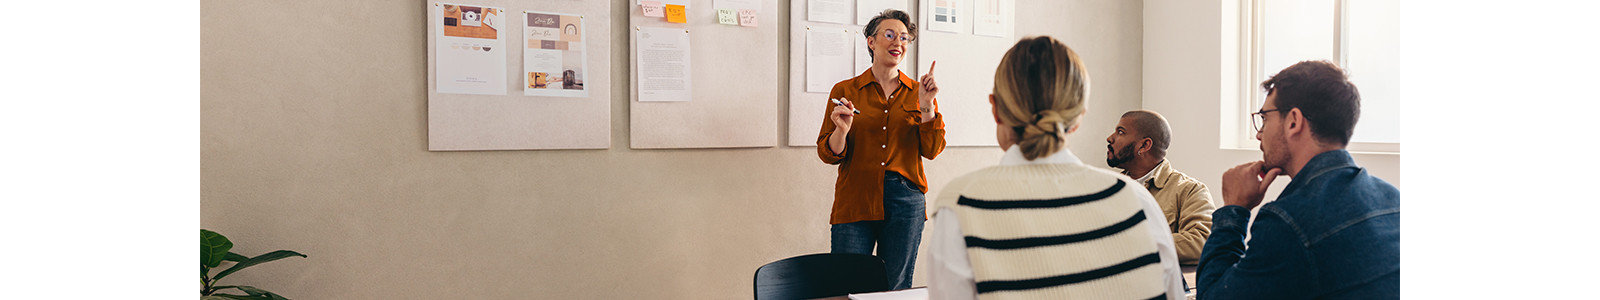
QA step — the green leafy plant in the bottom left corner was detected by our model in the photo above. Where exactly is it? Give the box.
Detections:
[200,230,306,300]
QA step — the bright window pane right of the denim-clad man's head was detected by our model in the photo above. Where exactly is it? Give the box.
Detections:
[1346,0,1403,144]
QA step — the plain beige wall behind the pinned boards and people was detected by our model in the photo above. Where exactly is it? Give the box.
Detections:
[200,0,1142,298]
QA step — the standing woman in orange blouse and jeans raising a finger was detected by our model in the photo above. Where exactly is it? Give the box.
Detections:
[816,10,944,289]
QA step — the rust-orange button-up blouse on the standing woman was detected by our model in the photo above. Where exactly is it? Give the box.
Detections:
[816,70,944,223]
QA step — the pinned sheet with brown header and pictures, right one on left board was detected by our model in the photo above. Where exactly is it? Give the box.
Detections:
[522,11,589,97]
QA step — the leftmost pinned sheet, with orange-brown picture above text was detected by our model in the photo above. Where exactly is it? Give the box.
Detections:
[432,3,506,94]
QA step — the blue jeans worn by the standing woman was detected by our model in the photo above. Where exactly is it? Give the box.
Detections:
[830,172,928,290]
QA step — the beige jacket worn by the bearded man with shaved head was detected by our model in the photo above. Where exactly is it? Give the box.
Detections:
[1123,160,1216,265]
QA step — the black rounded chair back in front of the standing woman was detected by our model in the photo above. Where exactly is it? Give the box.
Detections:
[755,254,890,300]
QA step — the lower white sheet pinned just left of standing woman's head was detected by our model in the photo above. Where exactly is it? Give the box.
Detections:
[805,27,854,93]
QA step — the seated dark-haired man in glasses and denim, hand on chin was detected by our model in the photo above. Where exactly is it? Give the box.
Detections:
[1197,61,1400,298]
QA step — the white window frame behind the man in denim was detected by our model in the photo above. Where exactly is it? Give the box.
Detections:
[1221,0,1400,155]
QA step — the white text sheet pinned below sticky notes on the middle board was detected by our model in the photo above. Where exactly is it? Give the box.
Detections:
[634,27,693,102]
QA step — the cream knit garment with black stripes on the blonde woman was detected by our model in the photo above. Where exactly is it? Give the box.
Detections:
[939,164,1166,300]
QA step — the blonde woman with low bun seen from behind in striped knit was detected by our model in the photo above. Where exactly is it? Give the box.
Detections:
[928,37,1184,298]
